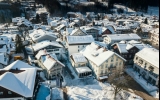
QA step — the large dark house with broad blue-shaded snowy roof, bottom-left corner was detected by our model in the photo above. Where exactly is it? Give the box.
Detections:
[0,60,40,100]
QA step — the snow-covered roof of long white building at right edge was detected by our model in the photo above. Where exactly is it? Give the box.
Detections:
[136,48,159,68]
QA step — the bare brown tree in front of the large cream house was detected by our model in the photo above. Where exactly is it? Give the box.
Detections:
[108,68,130,100]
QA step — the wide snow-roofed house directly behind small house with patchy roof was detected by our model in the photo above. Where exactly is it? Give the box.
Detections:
[25,40,65,59]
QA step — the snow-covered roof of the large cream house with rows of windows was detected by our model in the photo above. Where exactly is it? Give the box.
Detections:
[80,42,126,66]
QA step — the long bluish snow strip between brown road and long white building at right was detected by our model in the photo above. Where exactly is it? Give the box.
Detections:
[125,68,159,97]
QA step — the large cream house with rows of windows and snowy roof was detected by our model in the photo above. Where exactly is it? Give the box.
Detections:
[80,42,126,80]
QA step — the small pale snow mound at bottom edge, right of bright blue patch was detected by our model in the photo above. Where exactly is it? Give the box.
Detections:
[52,87,63,100]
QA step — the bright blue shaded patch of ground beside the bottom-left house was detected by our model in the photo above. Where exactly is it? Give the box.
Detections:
[36,82,50,100]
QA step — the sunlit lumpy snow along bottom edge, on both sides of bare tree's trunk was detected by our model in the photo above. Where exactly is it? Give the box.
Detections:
[67,82,143,100]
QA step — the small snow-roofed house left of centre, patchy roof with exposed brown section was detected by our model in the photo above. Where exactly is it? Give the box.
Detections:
[35,50,65,79]
